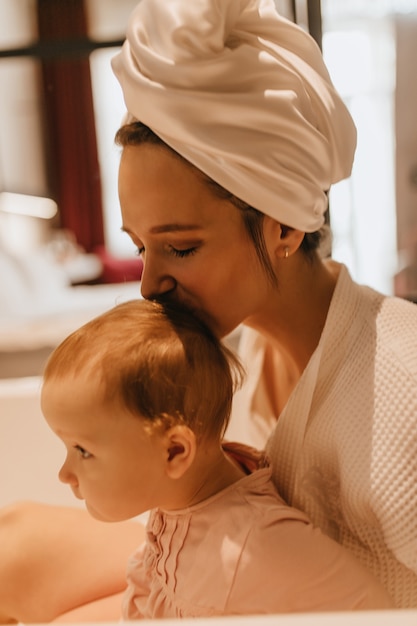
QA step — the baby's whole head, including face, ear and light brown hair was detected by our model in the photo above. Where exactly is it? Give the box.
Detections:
[41,300,241,521]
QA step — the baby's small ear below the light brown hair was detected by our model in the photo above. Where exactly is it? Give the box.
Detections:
[165,424,197,480]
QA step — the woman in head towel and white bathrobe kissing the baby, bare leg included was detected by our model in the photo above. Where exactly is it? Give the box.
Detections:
[0,0,417,621]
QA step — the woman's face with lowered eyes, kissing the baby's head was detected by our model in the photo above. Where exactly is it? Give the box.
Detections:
[119,143,271,336]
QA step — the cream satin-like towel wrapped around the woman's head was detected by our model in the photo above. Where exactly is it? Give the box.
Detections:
[112,0,356,232]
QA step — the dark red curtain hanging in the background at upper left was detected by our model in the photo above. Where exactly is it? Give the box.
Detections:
[38,0,104,252]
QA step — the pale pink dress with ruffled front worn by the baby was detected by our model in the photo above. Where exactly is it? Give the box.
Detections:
[123,444,392,620]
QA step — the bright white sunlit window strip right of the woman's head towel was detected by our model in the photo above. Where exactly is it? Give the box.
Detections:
[323,20,397,293]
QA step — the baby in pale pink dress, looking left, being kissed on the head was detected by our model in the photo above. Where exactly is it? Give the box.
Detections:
[41,300,392,619]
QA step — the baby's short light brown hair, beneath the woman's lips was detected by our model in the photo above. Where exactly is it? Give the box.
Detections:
[44,300,243,439]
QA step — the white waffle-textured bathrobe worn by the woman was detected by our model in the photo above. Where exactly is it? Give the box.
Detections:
[229,260,417,607]
